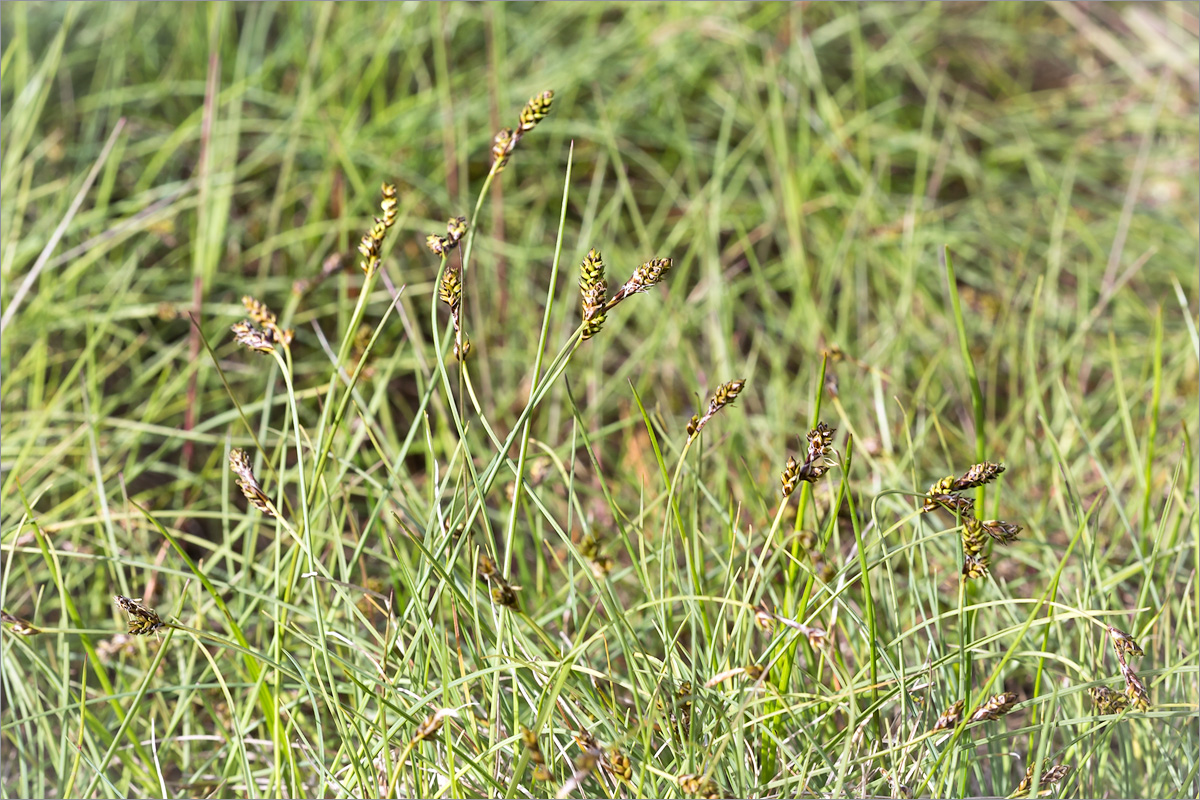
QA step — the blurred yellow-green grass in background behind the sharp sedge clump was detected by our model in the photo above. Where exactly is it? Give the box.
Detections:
[0,2,1200,796]
